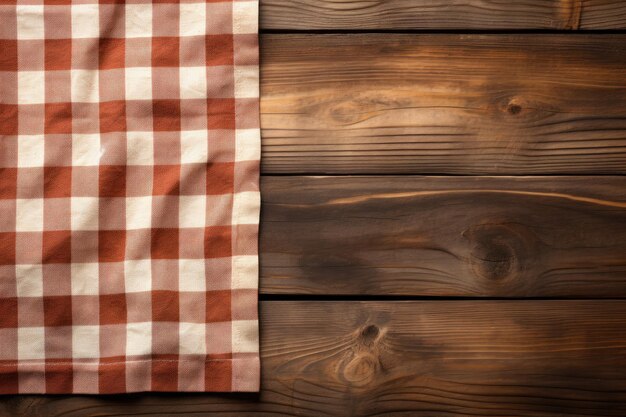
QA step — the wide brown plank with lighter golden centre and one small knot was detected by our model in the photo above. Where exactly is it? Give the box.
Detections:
[261,34,626,175]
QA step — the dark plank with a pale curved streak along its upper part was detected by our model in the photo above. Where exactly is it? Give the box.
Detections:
[261,176,626,297]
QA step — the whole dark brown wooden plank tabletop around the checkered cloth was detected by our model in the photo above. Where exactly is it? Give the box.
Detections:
[0,0,626,417]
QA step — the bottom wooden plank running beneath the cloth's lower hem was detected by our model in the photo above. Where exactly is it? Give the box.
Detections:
[8,301,626,417]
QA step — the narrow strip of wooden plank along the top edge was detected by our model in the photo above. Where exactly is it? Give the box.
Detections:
[261,0,626,30]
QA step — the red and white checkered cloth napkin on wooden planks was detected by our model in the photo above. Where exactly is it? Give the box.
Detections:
[0,0,260,393]
